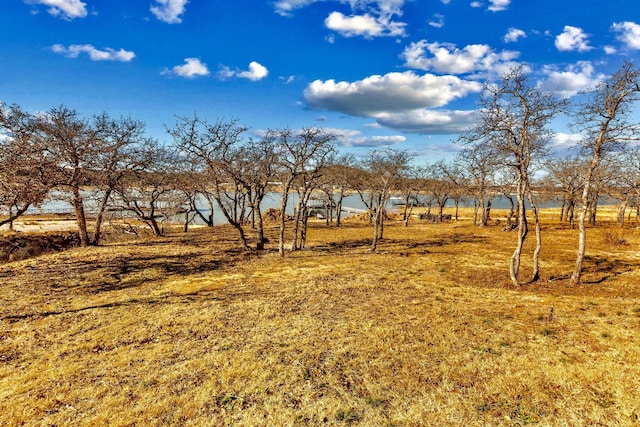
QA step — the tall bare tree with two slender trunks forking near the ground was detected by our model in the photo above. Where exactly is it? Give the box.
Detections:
[463,65,566,286]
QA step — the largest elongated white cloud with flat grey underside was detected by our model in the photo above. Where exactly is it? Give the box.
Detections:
[304,71,482,117]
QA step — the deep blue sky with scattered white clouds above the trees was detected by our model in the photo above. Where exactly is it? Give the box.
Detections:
[0,0,640,160]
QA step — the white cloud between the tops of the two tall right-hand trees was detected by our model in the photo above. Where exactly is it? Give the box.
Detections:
[538,61,605,98]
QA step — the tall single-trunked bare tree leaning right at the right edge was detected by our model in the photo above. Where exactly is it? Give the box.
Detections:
[571,62,640,283]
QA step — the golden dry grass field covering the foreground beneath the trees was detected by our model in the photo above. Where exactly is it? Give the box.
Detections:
[0,207,640,426]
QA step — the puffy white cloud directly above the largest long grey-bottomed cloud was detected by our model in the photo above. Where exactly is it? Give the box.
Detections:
[401,40,520,74]
